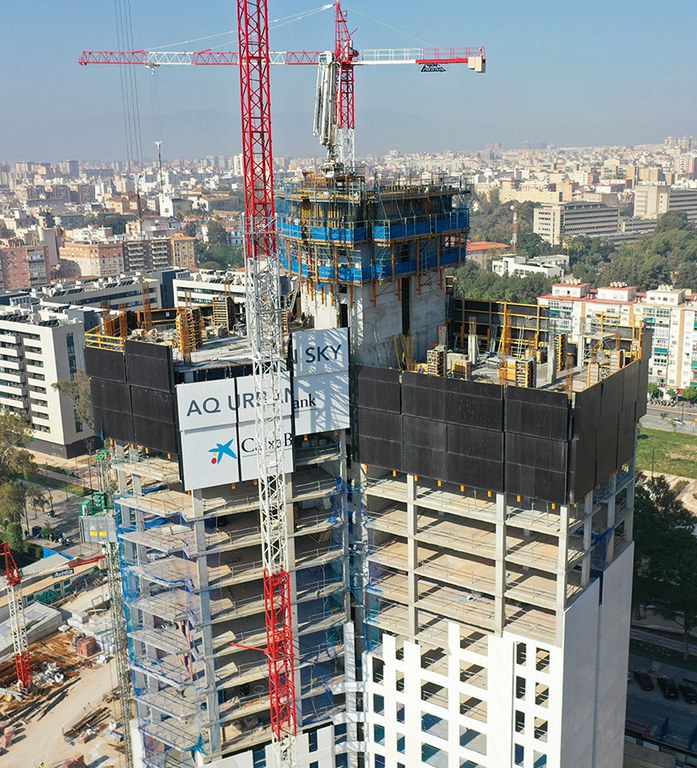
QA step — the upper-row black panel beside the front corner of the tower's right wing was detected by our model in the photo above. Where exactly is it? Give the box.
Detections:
[505,387,569,440]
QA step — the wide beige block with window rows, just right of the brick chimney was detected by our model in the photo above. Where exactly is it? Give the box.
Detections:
[533,202,620,245]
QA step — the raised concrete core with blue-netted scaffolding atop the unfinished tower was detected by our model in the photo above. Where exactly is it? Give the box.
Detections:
[276,170,469,365]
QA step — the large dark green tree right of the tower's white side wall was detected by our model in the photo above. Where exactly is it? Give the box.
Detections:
[633,475,697,658]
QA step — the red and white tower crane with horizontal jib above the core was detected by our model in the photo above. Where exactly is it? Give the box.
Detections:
[78,0,486,169]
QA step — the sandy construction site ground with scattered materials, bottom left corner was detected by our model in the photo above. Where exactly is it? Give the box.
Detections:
[0,632,123,768]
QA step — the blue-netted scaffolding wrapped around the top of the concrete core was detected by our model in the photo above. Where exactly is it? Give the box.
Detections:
[277,174,469,290]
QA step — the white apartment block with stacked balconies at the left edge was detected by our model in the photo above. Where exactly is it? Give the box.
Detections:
[0,308,92,457]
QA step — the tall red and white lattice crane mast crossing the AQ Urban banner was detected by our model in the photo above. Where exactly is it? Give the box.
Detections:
[237,0,297,768]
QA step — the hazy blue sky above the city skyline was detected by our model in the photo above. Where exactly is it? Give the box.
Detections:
[0,0,697,161]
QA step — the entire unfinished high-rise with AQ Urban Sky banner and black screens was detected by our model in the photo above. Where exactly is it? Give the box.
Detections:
[85,169,650,768]
